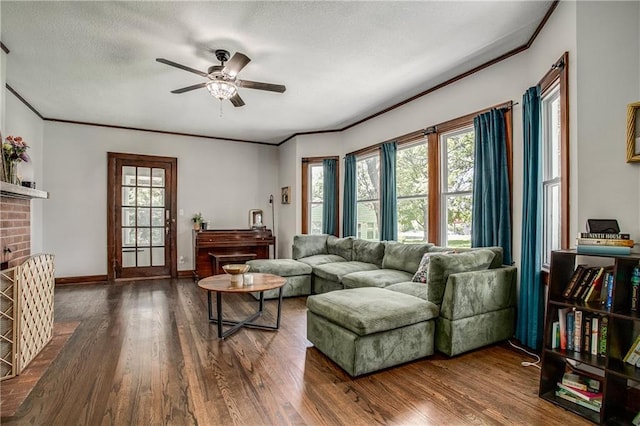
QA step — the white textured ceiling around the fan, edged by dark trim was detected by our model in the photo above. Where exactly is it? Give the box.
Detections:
[0,0,551,143]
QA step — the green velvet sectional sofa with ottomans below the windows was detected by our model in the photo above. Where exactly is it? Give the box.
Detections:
[247,235,516,375]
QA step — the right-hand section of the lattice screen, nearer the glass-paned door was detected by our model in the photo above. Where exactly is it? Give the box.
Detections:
[16,254,55,374]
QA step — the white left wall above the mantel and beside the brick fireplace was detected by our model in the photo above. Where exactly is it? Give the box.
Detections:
[2,90,49,254]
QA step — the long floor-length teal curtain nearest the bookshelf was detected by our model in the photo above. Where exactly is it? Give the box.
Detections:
[516,86,544,349]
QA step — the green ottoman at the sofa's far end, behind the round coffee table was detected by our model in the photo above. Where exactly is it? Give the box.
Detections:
[247,259,311,299]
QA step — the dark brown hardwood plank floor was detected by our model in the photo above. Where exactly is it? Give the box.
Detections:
[2,279,589,425]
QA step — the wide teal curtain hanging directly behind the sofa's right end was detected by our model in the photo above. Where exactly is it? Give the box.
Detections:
[471,108,511,265]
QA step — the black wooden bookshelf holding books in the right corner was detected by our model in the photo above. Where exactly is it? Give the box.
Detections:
[538,250,640,424]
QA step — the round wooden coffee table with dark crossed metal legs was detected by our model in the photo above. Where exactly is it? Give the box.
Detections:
[198,272,286,339]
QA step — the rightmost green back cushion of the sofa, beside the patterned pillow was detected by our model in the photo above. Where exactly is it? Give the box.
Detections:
[427,248,496,305]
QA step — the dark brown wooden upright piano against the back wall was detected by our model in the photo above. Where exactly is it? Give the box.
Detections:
[193,229,276,281]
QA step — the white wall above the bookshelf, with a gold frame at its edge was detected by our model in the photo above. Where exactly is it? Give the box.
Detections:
[577,2,640,240]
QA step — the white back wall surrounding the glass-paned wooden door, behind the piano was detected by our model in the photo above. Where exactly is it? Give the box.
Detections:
[44,122,278,277]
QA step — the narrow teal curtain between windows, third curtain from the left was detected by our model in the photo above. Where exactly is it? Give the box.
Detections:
[380,142,398,241]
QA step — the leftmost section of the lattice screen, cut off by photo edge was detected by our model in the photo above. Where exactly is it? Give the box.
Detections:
[0,267,18,380]
